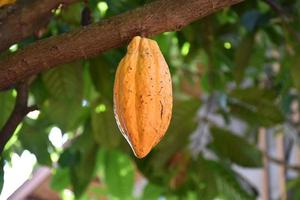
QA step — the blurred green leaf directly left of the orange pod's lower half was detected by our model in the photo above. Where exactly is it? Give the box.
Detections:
[92,99,123,148]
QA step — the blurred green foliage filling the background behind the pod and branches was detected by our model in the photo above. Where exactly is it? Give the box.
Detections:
[0,0,300,200]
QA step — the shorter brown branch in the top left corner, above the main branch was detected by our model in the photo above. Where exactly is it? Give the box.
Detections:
[0,0,78,52]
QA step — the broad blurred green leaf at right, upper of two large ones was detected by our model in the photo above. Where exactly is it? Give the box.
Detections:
[229,88,284,127]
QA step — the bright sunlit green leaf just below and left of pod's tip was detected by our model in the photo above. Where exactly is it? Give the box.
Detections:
[104,150,134,199]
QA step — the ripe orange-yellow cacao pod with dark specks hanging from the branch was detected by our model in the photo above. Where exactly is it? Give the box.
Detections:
[114,36,173,158]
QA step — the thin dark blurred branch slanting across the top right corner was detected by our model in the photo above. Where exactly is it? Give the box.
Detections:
[265,0,300,42]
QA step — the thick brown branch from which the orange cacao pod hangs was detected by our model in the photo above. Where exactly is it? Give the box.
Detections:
[0,0,242,90]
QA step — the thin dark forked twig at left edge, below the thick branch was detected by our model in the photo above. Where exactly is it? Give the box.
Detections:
[0,82,38,154]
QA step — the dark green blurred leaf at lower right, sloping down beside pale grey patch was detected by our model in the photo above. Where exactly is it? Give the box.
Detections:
[210,127,262,167]
